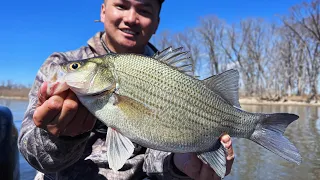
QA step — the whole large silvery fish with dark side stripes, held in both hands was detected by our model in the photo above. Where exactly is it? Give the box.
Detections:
[46,48,301,177]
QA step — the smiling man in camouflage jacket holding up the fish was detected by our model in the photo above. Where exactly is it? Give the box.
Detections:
[19,0,234,179]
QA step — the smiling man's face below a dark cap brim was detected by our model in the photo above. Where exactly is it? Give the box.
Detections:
[100,0,160,53]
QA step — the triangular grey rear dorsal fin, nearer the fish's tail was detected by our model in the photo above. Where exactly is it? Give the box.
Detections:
[203,69,240,108]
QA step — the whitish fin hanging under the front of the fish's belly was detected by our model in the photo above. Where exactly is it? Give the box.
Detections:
[106,127,134,170]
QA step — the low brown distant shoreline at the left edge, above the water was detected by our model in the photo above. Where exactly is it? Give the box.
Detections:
[0,80,31,98]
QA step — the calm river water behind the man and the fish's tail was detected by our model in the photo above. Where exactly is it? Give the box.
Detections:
[0,99,320,180]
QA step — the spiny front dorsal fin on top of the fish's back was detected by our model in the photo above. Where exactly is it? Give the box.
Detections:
[153,47,195,77]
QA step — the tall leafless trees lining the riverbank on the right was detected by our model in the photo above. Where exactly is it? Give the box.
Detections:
[153,0,320,102]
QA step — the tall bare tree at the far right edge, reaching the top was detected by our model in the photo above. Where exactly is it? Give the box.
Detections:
[282,0,320,101]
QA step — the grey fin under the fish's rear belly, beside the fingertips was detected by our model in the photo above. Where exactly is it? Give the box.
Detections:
[198,142,227,178]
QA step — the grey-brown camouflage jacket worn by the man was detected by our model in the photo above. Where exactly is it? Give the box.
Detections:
[19,32,189,180]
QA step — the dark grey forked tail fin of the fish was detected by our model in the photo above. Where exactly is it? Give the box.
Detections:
[250,113,301,165]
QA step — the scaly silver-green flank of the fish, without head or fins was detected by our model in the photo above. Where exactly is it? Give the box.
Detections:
[105,55,257,152]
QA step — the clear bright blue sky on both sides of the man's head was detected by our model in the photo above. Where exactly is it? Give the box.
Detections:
[0,0,310,85]
